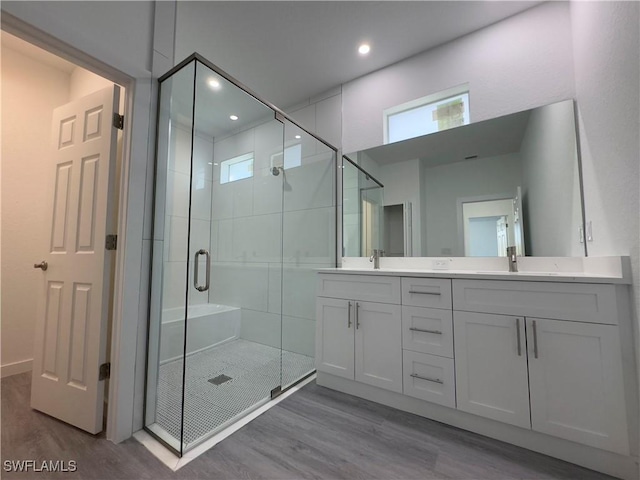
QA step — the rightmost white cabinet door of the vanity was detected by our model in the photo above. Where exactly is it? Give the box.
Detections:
[527,318,629,455]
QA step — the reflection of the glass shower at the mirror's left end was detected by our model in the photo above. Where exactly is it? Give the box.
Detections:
[342,157,384,257]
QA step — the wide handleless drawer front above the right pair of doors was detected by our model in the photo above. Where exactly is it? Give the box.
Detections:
[453,280,618,325]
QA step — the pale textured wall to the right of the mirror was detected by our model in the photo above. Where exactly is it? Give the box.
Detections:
[571,2,640,462]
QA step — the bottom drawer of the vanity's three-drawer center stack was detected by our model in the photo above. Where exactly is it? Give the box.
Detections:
[402,350,456,408]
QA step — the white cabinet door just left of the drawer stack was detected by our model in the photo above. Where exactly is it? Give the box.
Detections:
[355,302,402,392]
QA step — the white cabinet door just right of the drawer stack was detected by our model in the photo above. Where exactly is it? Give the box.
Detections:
[453,312,531,428]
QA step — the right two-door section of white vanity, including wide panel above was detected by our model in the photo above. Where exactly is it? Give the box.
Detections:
[453,280,629,455]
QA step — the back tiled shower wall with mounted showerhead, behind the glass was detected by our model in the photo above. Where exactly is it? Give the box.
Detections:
[210,120,335,356]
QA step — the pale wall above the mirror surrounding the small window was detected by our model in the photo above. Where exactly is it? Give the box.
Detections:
[342,2,575,152]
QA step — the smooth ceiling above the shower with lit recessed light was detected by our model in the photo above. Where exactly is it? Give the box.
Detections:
[176,1,542,108]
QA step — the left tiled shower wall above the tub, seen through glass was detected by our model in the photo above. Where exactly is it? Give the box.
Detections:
[162,123,213,309]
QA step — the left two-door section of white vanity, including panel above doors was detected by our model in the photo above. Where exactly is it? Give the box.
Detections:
[316,275,402,392]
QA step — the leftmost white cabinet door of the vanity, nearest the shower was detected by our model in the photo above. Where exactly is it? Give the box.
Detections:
[316,297,355,380]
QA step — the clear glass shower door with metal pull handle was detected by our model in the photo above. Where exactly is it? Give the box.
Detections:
[183,63,283,449]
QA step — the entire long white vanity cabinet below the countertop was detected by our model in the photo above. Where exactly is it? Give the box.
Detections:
[316,271,637,478]
